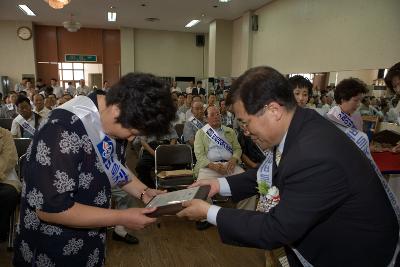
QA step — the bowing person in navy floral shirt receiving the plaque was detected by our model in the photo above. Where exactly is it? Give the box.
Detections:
[14,73,176,266]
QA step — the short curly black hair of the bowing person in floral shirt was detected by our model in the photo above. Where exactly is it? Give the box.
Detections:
[106,73,176,136]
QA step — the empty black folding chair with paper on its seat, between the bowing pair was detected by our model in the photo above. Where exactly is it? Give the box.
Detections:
[154,144,195,190]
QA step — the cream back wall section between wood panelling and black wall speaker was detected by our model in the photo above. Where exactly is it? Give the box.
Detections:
[131,29,208,78]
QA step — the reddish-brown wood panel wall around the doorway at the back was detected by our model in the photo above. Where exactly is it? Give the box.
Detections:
[34,25,121,87]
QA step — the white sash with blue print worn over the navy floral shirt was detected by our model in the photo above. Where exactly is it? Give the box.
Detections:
[58,96,130,186]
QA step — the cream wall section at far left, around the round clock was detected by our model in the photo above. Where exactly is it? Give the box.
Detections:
[0,21,36,89]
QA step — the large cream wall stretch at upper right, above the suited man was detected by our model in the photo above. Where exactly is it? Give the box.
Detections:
[252,0,400,73]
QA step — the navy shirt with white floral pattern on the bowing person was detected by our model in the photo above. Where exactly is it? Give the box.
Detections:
[14,95,126,266]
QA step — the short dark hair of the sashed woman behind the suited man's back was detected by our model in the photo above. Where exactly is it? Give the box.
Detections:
[334,78,368,104]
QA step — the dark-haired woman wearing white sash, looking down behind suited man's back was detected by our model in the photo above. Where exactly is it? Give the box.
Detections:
[327,78,368,131]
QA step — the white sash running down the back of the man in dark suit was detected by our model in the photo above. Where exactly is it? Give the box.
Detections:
[324,121,400,267]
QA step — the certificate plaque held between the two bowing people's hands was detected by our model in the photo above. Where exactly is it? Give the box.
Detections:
[146,185,211,218]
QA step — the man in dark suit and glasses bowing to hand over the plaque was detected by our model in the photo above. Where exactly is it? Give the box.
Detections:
[178,67,399,267]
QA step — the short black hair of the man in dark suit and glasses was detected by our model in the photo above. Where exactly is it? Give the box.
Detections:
[226,66,297,115]
